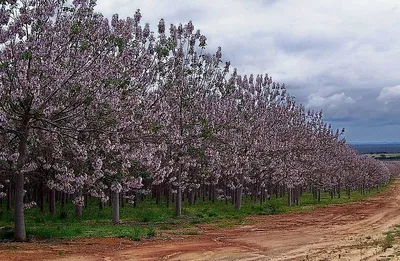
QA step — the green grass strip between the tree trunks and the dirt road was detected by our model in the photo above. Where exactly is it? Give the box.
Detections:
[0,182,390,241]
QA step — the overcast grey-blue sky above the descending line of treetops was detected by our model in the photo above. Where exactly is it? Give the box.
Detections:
[97,0,400,142]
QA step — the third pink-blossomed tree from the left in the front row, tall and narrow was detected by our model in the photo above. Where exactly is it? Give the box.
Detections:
[142,20,227,216]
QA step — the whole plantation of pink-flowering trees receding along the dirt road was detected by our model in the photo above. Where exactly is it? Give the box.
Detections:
[0,0,397,241]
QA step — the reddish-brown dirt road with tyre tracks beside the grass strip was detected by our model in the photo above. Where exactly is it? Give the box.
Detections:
[0,179,400,261]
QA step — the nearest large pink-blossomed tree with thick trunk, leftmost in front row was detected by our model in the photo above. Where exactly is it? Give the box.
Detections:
[0,0,150,241]
